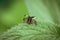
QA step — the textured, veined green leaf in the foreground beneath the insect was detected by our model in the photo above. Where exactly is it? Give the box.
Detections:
[0,22,60,40]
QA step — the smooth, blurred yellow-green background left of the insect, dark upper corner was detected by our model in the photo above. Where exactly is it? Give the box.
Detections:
[0,0,28,33]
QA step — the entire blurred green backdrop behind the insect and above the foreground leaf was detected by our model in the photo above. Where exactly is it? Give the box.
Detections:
[0,0,60,33]
